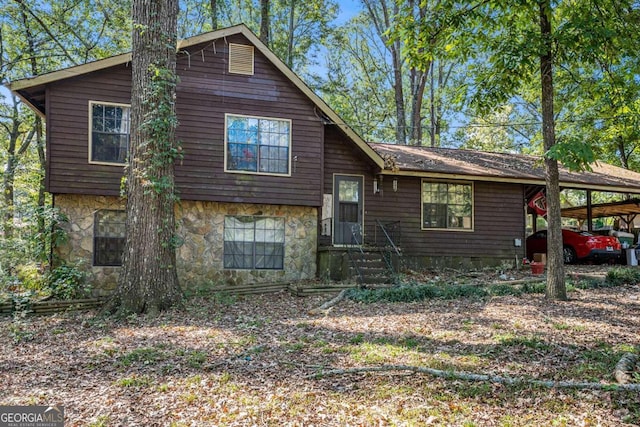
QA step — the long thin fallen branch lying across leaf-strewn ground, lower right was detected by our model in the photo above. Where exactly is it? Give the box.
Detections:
[305,365,640,391]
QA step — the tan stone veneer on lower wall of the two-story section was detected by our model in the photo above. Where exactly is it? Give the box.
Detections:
[55,194,318,295]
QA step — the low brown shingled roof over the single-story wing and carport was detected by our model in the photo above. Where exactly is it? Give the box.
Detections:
[370,144,640,194]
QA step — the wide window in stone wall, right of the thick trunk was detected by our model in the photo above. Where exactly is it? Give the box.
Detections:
[224,216,284,270]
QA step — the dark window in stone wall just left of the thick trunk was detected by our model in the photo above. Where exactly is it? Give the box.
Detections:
[93,209,127,266]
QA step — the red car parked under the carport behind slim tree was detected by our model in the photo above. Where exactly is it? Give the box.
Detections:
[526,229,622,264]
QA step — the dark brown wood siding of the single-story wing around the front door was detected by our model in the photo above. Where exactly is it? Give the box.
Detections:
[322,128,525,259]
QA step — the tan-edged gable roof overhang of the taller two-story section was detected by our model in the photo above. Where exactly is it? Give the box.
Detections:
[8,24,384,168]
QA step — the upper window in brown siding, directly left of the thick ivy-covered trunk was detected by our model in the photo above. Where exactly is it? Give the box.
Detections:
[89,101,131,165]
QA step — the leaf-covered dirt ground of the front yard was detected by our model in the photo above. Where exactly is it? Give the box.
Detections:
[0,266,640,426]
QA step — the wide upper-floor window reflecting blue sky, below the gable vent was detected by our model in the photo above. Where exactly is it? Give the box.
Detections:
[225,114,291,175]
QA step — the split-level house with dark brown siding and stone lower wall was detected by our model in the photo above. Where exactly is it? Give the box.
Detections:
[10,25,640,293]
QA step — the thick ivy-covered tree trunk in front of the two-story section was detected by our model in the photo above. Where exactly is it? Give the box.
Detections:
[107,0,182,314]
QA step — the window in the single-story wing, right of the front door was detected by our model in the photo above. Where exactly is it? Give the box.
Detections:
[422,181,473,231]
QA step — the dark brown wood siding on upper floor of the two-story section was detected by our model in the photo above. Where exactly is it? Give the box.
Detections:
[47,35,324,206]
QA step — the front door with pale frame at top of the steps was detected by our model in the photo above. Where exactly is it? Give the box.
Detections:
[333,175,364,245]
